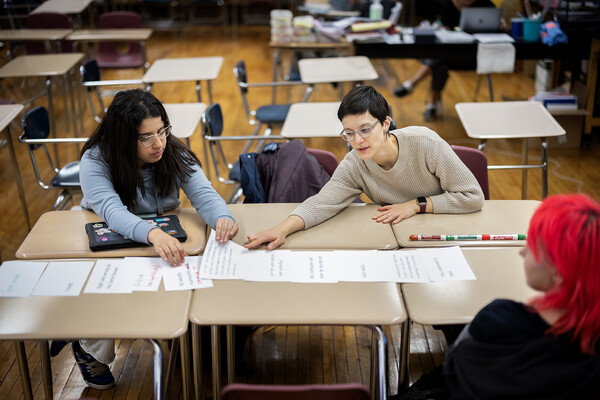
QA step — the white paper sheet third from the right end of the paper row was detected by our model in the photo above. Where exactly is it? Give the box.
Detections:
[334,250,394,282]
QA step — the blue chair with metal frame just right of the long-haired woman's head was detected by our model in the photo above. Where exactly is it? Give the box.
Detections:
[202,103,286,203]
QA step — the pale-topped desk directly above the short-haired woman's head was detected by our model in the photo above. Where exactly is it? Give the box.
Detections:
[298,56,379,102]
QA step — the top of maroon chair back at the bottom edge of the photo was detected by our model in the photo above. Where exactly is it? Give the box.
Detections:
[221,383,371,400]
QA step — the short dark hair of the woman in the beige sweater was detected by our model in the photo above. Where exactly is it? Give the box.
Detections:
[338,85,390,122]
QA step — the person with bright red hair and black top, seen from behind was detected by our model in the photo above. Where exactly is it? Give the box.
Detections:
[397,194,600,399]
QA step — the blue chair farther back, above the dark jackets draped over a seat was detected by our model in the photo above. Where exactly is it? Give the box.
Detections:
[233,61,304,153]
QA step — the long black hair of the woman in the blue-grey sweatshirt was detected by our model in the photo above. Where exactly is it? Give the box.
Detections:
[81,89,200,211]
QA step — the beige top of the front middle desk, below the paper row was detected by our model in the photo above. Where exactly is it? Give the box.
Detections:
[190,280,406,325]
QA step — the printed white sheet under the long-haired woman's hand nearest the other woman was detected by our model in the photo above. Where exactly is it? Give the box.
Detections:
[200,231,248,279]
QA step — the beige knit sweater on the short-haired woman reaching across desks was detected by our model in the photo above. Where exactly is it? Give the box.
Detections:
[292,126,484,229]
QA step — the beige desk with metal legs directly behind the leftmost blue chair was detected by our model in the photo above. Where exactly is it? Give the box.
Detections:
[0,53,83,165]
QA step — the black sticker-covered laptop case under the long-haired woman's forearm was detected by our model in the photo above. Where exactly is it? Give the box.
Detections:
[85,215,187,251]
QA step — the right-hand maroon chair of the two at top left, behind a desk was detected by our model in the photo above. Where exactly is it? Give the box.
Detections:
[96,11,146,68]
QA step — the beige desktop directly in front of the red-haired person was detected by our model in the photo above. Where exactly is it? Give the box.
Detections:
[402,247,539,325]
